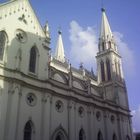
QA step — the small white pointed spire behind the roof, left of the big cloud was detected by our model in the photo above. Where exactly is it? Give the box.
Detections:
[55,30,65,63]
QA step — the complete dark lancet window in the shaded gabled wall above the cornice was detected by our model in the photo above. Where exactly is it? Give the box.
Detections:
[29,46,38,73]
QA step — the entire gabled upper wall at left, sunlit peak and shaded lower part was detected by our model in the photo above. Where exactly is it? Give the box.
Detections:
[0,0,49,74]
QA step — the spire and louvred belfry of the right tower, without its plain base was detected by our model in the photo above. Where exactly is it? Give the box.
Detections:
[96,8,123,84]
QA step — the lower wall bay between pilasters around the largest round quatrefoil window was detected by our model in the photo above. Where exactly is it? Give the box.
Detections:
[18,87,42,140]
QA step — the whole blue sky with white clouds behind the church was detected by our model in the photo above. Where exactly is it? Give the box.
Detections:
[0,0,140,132]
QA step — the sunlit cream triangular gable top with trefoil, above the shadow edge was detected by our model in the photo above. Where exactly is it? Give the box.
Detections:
[0,0,45,37]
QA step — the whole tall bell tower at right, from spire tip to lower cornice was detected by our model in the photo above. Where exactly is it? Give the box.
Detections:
[96,8,128,107]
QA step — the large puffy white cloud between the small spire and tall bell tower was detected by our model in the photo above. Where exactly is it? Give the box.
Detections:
[69,21,98,68]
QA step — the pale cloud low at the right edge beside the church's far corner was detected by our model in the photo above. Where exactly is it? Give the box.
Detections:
[132,106,140,132]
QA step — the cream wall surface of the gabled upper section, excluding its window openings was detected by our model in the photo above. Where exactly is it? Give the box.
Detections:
[0,1,49,80]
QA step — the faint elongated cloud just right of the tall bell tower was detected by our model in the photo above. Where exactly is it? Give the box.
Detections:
[113,32,135,76]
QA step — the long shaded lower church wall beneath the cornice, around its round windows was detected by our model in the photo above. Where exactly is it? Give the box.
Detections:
[1,77,131,140]
